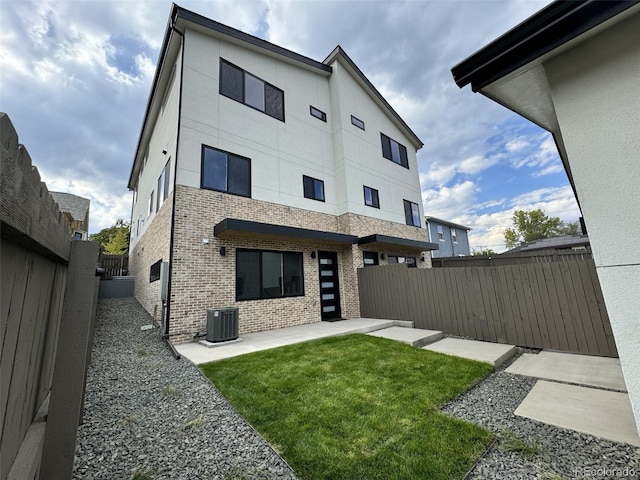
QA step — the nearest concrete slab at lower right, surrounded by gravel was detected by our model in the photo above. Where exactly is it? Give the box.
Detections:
[515,380,640,447]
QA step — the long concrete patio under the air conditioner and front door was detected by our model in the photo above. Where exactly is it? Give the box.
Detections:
[175,318,413,365]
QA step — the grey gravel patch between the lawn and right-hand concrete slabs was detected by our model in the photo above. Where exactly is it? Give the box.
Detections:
[442,349,640,480]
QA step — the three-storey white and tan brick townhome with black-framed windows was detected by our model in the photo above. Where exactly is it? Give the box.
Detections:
[128,5,437,343]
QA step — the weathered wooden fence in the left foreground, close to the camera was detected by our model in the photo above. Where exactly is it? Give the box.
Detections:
[0,113,99,480]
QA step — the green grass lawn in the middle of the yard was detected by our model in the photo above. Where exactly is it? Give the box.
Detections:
[201,334,493,480]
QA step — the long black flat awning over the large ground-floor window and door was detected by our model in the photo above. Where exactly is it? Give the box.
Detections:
[213,218,358,245]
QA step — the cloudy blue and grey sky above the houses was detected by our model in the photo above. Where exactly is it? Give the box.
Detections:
[0,0,579,251]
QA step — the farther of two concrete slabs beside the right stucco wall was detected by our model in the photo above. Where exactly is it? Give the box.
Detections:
[506,351,627,392]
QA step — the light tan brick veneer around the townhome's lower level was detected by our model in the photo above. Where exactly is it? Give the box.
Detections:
[132,185,430,343]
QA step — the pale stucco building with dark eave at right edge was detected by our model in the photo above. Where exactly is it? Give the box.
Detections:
[452,1,640,431]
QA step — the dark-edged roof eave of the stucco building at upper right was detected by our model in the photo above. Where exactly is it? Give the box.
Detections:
[451,0,640,215]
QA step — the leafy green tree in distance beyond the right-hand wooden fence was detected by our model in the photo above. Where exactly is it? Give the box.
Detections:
[504,209,581,249]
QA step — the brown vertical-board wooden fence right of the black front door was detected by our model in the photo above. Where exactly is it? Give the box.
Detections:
[358,259,617,357]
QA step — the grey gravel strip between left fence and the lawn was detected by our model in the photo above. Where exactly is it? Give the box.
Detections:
[73,298,296,480]
